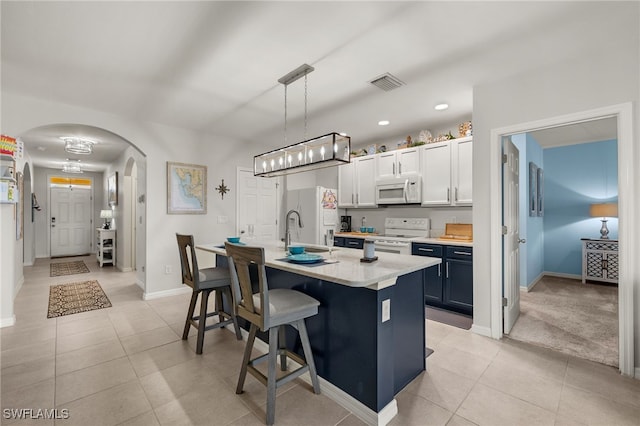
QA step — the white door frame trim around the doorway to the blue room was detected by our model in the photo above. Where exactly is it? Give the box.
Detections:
[489,102,640,376]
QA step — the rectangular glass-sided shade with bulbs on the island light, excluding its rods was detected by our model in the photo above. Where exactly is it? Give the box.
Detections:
[253,132,351,177]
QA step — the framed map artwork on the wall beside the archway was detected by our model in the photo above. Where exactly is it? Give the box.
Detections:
[167,161,207,214]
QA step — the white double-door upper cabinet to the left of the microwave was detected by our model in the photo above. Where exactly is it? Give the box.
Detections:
[338,156,376,208]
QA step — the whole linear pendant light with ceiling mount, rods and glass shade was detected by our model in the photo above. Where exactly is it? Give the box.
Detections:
[253,64,351,177]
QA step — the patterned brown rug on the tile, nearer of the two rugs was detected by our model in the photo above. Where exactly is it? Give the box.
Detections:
[47,280,111,318]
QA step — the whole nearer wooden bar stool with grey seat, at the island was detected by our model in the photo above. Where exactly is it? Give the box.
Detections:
[225,243,320,425]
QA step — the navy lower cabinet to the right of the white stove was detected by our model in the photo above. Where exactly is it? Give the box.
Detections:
[412,243,473,315]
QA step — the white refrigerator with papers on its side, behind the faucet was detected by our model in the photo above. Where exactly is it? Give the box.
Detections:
[285,186,340,245]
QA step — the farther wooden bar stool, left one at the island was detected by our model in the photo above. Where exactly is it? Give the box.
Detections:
[176,234,242,354]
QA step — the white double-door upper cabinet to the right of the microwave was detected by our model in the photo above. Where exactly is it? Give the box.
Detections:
[421,137,473,206]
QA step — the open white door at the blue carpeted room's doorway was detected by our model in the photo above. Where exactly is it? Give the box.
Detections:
[502,137,524,334]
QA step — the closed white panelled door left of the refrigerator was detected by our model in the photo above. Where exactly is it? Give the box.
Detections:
[236,169,278,240]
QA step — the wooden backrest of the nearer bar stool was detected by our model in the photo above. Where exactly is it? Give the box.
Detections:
[225,242,270,331]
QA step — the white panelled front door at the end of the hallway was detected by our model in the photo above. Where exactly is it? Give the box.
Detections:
[49,187,92,257]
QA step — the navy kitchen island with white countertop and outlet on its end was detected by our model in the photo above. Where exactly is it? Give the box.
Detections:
[197,242,440,424]
